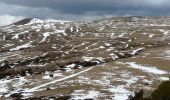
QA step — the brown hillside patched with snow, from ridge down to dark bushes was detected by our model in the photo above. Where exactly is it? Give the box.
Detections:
[0,17,170,100]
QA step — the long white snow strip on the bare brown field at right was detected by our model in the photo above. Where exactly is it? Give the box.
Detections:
[126,62,168,75]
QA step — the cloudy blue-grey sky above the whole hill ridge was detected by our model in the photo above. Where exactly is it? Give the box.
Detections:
[0,0,170,26]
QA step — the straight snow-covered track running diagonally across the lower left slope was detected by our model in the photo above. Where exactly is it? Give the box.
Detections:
[24,67,94,92]
